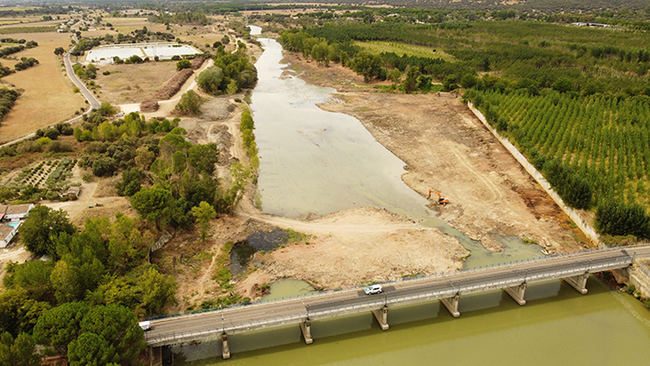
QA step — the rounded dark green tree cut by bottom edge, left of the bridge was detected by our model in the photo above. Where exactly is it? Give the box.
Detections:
[68,333,120,366]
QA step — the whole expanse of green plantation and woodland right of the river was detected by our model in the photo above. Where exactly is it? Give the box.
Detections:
[281,15,650,236]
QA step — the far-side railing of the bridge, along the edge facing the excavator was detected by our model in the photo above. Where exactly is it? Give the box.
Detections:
[148,244,644,320]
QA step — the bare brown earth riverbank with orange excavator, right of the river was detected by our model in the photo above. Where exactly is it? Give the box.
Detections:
[285,53,586,253]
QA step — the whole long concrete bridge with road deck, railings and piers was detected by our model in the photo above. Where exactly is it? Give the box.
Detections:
[145,244,650,359]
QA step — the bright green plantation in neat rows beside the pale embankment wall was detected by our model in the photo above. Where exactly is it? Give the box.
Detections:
[474,91,650,208]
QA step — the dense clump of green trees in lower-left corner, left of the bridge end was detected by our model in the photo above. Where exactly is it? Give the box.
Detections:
[0,206,168,365]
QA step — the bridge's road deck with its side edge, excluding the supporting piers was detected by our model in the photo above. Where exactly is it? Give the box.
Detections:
[145,244,650,345]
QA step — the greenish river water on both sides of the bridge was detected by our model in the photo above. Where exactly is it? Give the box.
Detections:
[174,27,650,365]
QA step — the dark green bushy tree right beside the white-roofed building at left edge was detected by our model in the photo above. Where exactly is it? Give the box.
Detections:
[20,205,75,258]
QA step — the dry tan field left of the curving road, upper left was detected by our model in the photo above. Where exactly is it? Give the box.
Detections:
[0,32,86,142]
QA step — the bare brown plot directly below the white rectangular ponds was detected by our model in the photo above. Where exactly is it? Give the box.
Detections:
[95,61,176,104]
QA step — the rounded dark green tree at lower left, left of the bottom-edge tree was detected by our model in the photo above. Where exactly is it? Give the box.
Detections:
[34,302,88,353]
